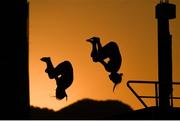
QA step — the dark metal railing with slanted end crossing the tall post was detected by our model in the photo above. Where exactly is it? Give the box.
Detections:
[127,80,180,108]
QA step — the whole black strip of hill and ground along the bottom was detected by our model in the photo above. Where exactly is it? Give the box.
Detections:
[30,99,180,120]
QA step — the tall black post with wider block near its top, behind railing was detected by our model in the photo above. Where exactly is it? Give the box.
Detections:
[156,0,176,111]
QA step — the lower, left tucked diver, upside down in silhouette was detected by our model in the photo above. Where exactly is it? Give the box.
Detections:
[40,57,73,100]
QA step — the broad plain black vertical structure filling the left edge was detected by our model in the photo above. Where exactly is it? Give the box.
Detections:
[0,0,30,119]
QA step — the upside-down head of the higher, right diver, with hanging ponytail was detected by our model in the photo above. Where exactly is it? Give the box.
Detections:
[109,72,123,91]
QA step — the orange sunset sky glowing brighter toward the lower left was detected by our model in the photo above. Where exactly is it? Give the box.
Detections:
[29,0,180,110]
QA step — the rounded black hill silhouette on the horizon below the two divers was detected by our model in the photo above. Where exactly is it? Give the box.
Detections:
[31,99,133,120]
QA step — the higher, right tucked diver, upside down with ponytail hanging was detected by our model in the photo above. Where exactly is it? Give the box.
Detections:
[86,37,123,91]
